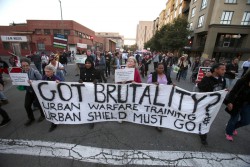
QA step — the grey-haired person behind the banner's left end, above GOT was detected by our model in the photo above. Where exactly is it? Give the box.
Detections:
[42,64,61,132]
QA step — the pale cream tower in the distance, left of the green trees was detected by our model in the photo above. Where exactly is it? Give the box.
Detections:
[136,21,154,50]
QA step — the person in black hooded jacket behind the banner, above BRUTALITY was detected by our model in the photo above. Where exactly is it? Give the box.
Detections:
[79,57,102,129]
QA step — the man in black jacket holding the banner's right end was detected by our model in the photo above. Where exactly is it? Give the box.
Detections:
[198,63,226,145]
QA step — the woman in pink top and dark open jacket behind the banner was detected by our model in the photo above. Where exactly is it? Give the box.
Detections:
[147,63,172,132]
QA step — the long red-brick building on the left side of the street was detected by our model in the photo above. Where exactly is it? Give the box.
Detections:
[0,20,105,56]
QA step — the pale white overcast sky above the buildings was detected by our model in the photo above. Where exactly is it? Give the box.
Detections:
[0,0,167,41]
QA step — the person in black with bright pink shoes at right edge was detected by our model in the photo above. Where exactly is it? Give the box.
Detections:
[224,70,250,141]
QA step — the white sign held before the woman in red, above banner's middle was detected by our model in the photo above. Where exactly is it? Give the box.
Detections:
[115,68,135,83]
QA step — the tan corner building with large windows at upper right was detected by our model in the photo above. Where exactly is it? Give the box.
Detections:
[188,0,250,61]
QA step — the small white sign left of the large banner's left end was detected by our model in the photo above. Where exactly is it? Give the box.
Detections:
[9,73,30,86]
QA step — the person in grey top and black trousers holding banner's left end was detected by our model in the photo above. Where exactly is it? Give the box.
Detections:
[21,58,44,126]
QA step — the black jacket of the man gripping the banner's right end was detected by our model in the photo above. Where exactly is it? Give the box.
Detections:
[198,76,226,92]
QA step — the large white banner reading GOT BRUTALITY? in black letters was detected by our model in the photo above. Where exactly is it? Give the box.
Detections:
[32,81,227,134]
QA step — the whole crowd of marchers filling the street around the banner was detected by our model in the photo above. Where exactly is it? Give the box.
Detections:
[0,50,250,145]
